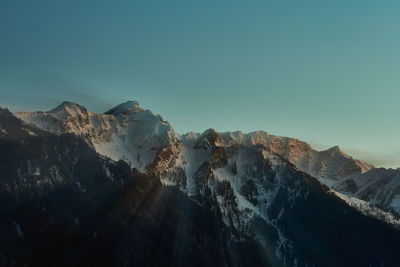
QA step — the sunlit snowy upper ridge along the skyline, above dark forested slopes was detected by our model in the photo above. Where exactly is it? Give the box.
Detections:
[15,101,400,220]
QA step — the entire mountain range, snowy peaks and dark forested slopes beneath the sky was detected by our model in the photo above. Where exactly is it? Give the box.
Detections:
[0,101,400,266]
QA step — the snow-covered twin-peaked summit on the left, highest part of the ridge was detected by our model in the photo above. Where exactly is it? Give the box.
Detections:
[15,101,177,171]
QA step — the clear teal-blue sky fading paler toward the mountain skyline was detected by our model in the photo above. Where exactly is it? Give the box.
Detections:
[0,0,400,167]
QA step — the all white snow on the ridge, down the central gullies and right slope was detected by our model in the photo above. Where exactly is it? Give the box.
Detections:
[11,101,400,266]
